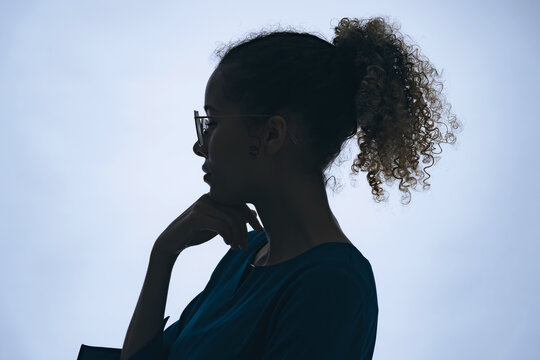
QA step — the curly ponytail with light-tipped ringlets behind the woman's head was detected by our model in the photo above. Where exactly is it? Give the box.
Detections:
[333,17,460,203]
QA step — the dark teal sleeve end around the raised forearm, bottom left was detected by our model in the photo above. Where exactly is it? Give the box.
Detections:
[77,292,206,360]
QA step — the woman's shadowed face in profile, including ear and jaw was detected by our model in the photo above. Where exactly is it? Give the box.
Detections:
[193,64,316,204]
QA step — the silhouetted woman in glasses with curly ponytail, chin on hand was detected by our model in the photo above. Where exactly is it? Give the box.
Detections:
[79,18,459,360]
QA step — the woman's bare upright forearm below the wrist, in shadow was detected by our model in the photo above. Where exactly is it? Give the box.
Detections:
[120,247,177,360]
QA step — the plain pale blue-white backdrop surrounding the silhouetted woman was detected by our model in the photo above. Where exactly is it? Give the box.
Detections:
[0,0,540,360]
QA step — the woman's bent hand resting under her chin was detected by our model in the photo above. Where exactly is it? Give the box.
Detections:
[154,193,264,256]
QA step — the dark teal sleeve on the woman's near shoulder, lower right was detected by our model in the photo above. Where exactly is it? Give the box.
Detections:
[263,266,378,360]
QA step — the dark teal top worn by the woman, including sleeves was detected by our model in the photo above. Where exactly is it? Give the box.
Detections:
[78,230,379,360]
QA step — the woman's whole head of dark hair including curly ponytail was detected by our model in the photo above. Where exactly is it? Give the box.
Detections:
[216,17,461,204]
